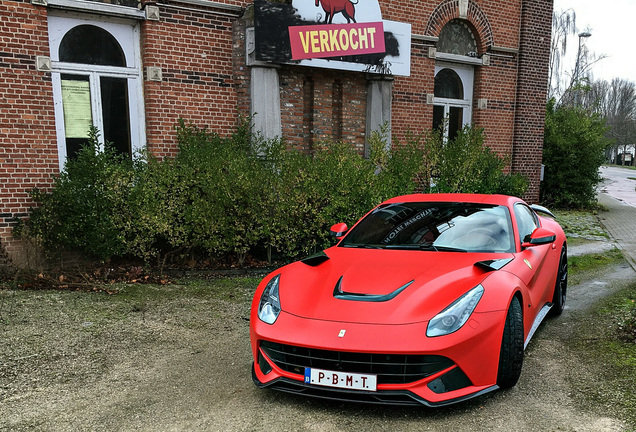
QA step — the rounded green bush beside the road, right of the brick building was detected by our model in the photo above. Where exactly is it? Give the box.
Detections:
[541,100,609,208]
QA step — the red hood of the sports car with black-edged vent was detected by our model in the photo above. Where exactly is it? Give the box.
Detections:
[277,247,512,324]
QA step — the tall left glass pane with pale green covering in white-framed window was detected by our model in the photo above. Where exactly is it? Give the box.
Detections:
[61,74,93,158]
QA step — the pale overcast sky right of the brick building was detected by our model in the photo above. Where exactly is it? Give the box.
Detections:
[554,0,636,82]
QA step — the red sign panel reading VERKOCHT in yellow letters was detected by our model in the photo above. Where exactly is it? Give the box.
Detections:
[289,22,384,60]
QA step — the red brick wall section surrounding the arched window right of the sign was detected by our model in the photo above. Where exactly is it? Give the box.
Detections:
[390,0,521,163]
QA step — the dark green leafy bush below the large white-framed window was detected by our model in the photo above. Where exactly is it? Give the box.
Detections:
[23,128,133,259]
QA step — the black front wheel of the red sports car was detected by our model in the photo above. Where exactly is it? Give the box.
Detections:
[497,297,523,389]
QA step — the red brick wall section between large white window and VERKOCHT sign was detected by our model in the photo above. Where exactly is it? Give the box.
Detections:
[141,1,237,156]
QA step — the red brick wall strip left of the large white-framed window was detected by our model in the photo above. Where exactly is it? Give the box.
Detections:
[0,1,59,264]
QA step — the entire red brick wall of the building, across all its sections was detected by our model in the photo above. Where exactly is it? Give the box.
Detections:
[0,0,552,264]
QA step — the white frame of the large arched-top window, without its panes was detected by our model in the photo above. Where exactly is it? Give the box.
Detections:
[48,11,146,170]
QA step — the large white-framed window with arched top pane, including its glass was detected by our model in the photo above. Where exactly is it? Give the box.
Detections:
[49,15,145,167]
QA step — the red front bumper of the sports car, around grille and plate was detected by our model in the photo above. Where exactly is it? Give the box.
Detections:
[250,312,504,406]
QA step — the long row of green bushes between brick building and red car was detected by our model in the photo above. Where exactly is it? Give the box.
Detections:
[18,119,525,266]
